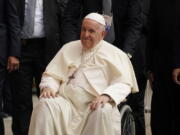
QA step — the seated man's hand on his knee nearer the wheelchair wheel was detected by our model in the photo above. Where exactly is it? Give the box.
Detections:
[90,95,111,111]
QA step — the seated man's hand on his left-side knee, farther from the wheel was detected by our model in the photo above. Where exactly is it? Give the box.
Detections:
[39,88,58,98]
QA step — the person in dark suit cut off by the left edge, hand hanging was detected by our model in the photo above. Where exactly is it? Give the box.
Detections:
[0,0,20,135]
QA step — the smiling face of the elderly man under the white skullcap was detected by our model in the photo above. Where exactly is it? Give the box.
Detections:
[80,19,105,49]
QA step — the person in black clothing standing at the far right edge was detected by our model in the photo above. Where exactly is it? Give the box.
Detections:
[147,0,180,135]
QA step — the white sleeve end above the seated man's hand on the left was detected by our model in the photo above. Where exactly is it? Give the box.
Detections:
[39,75,60,92]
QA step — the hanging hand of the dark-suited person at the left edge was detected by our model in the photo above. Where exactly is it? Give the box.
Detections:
[7,56,19,72]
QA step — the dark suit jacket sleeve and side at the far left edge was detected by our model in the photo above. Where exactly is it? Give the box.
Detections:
[0,0,20,66]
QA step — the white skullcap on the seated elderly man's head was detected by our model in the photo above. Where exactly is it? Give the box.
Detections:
[84,13,106,26]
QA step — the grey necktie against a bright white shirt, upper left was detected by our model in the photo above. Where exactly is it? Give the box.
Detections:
[23,0,36,37]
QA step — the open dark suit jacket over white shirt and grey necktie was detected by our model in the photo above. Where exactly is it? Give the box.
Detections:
[17,0,64,64]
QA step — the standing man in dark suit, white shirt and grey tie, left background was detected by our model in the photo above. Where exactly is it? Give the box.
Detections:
[8,0,66,135]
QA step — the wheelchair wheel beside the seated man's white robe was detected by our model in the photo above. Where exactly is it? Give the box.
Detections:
[119,104,135,135]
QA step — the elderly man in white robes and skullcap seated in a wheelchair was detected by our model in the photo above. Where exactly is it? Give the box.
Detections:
[29,13,138,135]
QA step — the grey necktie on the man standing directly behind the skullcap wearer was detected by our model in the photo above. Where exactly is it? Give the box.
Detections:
[102,0,115,43]
